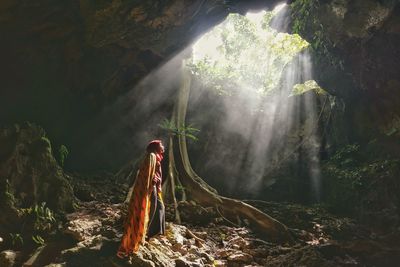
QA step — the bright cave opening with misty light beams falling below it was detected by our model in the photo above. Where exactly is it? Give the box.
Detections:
[187,4,329,201]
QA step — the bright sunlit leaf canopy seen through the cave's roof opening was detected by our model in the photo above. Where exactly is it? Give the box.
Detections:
[190,6,319,96]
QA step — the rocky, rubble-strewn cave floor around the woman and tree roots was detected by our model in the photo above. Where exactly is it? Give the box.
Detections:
[3,174,400,267]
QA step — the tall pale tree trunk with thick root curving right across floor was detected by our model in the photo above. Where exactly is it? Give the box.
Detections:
[165,61,293,242]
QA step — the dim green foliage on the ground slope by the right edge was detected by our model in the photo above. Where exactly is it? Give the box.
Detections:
[322,144,400,213]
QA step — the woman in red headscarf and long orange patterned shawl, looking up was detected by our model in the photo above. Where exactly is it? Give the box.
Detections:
[117,140,165,258]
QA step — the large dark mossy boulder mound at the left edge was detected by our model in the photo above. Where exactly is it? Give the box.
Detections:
[0,123,75,222]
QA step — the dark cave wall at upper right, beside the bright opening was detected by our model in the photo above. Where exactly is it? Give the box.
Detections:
[292,0,400,141]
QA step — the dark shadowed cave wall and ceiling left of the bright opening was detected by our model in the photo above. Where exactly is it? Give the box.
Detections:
[0,0,277,169]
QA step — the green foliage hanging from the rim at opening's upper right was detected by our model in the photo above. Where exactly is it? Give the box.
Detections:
[291,0,344,69]
